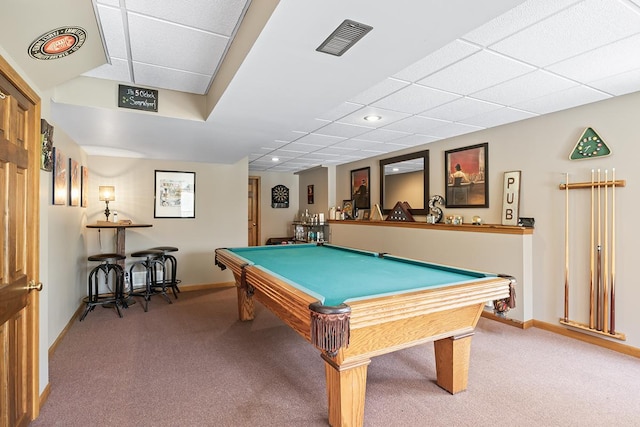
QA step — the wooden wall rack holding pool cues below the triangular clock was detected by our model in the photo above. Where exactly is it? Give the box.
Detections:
[559,169,627,341]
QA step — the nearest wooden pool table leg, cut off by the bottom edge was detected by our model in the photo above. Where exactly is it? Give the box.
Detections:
[322,355,371,427]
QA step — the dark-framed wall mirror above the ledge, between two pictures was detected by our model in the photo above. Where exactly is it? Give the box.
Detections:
[380,150,429,215]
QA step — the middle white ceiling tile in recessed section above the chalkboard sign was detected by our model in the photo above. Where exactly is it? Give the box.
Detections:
[127,13,229,75]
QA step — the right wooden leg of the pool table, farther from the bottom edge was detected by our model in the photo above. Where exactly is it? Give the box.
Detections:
[433,332,473,394]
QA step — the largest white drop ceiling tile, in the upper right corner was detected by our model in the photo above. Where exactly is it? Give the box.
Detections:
[491,0,640,67]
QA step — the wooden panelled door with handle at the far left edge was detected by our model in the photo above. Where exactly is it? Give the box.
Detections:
[0,56,40,427]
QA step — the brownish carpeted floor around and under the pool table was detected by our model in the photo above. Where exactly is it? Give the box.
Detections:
[31,289,640,427]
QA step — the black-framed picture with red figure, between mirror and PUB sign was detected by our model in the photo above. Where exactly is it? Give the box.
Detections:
[444,142,489,208]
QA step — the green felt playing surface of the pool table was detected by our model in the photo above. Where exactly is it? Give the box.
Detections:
[229,244,496,305]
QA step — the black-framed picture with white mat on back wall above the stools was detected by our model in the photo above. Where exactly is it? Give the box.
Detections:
[153,170,196,218]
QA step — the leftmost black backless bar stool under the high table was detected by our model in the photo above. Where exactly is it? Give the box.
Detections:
[80,253,126,322]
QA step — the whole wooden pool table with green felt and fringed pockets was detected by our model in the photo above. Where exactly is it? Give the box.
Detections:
[215,243,515,426]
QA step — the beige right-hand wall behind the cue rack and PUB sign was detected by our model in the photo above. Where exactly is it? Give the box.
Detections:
[336,93,640,347]
